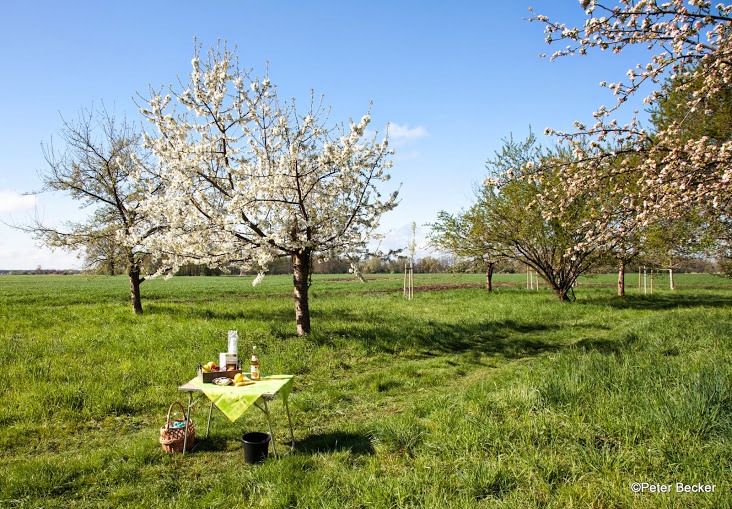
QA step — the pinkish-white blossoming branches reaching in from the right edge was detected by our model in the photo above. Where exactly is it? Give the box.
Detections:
[531,0,732,252]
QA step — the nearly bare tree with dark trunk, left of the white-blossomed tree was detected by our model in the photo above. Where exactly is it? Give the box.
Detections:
[16,108,160,314]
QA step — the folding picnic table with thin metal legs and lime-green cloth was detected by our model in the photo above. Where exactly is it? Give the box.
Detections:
[178,375,295,457]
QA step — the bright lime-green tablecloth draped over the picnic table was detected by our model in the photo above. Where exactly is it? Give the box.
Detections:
[189,375,293,422]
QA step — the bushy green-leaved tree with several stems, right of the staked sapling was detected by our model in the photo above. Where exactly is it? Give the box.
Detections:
[431,132,603,300]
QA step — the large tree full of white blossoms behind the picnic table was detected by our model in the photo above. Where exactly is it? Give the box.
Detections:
[141,45,397,335]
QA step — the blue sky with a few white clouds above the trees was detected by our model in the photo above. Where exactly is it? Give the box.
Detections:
[0,0,648,269]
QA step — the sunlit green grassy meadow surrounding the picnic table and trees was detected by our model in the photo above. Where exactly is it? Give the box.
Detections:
[0,274,732,509]
